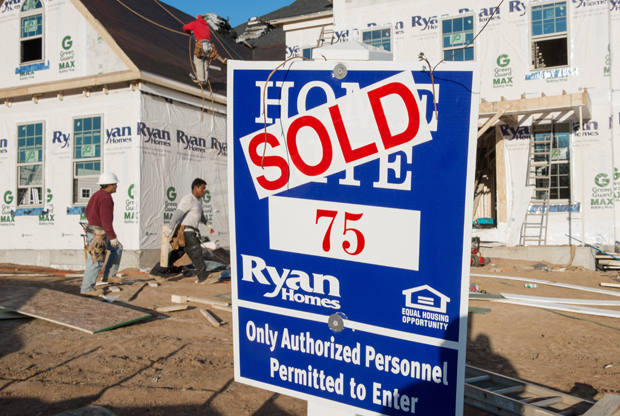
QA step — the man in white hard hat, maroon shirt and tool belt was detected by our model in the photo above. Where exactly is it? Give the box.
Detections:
[80,172,123,296]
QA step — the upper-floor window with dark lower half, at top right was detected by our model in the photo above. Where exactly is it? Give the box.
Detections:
[530,1,568,69]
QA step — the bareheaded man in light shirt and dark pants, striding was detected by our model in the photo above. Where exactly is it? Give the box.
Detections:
[150,178,220,284]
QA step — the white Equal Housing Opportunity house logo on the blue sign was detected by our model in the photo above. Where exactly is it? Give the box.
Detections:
[402,285,450,331]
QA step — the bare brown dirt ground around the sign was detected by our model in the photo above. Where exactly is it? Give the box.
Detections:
[0,259,620,416]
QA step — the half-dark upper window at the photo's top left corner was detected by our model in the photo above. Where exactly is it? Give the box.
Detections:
[19,0,43,64]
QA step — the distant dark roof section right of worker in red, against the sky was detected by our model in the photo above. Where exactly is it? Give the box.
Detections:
[235,0,333,52]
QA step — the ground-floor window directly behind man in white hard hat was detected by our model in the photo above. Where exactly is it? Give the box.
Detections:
[73,116,101,204]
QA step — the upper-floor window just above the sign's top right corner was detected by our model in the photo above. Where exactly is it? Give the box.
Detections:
[441,16,474,61]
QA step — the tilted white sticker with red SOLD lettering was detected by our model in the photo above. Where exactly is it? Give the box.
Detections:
[241,71,432,199]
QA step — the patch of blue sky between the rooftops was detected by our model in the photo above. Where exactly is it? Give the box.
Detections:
[163,0,295,27]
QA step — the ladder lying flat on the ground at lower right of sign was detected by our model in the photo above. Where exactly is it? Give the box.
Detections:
[465,365,594,416]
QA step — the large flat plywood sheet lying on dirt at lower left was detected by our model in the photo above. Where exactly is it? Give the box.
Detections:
[0,286,151,334]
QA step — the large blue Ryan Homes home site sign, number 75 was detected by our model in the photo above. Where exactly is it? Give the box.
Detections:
[228,61,479,416]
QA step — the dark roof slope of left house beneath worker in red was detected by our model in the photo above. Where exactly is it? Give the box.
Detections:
[80,0,251,95]
